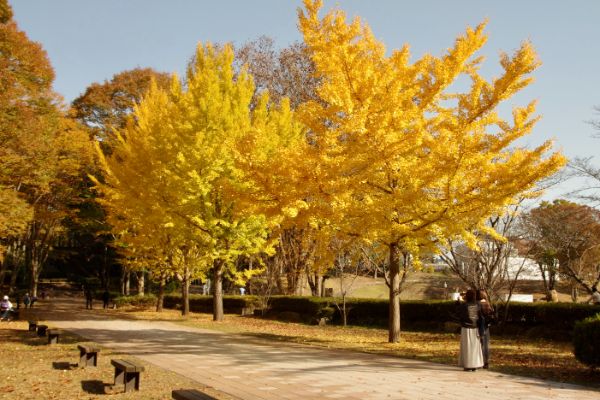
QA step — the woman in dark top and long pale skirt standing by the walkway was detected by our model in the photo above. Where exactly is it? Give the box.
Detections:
[457,289,483,371]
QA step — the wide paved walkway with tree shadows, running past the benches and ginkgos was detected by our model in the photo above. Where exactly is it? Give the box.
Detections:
[38,299,600,400]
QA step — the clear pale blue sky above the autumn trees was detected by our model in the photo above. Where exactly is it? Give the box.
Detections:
[9,0,600,196]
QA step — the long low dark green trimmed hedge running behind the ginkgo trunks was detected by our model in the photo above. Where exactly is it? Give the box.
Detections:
[125,294,600,339]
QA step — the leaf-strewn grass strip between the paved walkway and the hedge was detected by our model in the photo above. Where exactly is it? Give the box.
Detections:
[110,308,600,388]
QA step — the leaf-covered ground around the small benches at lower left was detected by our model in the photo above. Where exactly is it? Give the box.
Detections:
[0,321,230,400]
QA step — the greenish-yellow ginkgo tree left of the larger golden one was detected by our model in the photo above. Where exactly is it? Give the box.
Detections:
[98,44,303,320]
